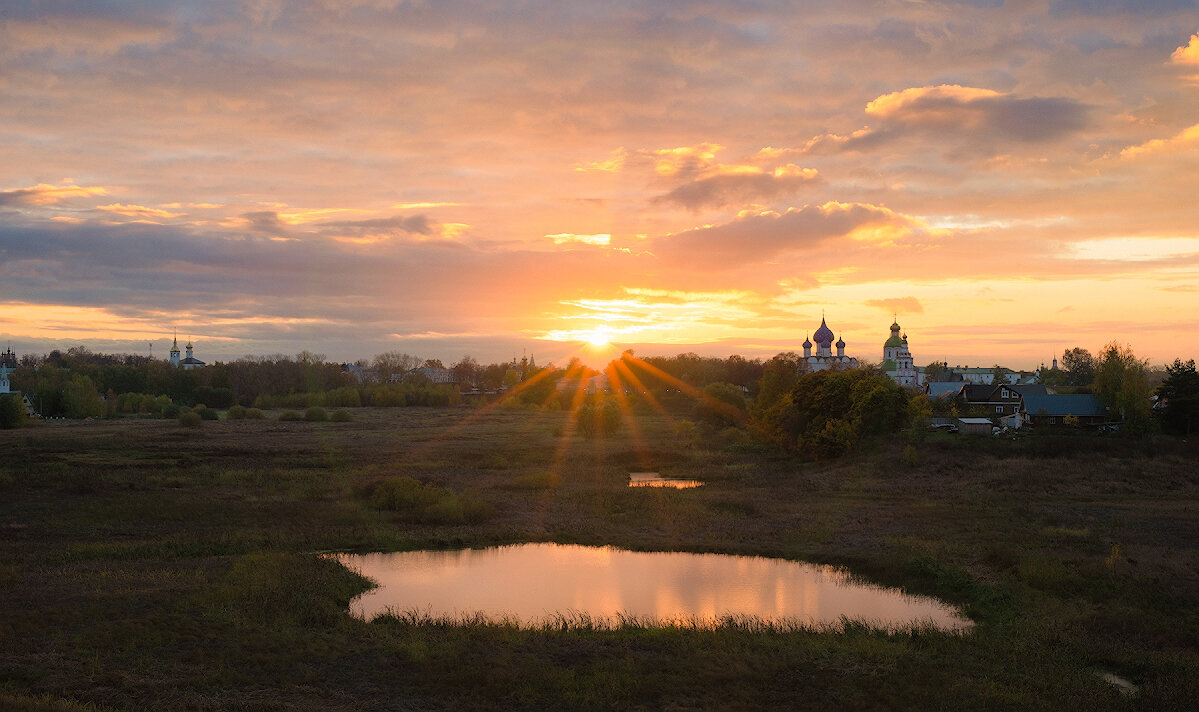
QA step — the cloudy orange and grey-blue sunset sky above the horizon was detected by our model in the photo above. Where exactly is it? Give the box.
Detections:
[0,0,1199,368]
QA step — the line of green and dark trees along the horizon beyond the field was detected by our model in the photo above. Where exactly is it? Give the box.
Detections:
[0,343,1199,441]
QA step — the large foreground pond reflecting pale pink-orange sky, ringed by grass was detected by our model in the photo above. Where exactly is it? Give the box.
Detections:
[337,544,971,630]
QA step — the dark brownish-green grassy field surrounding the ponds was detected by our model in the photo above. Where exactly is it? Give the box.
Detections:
[0,408,1199,711]
